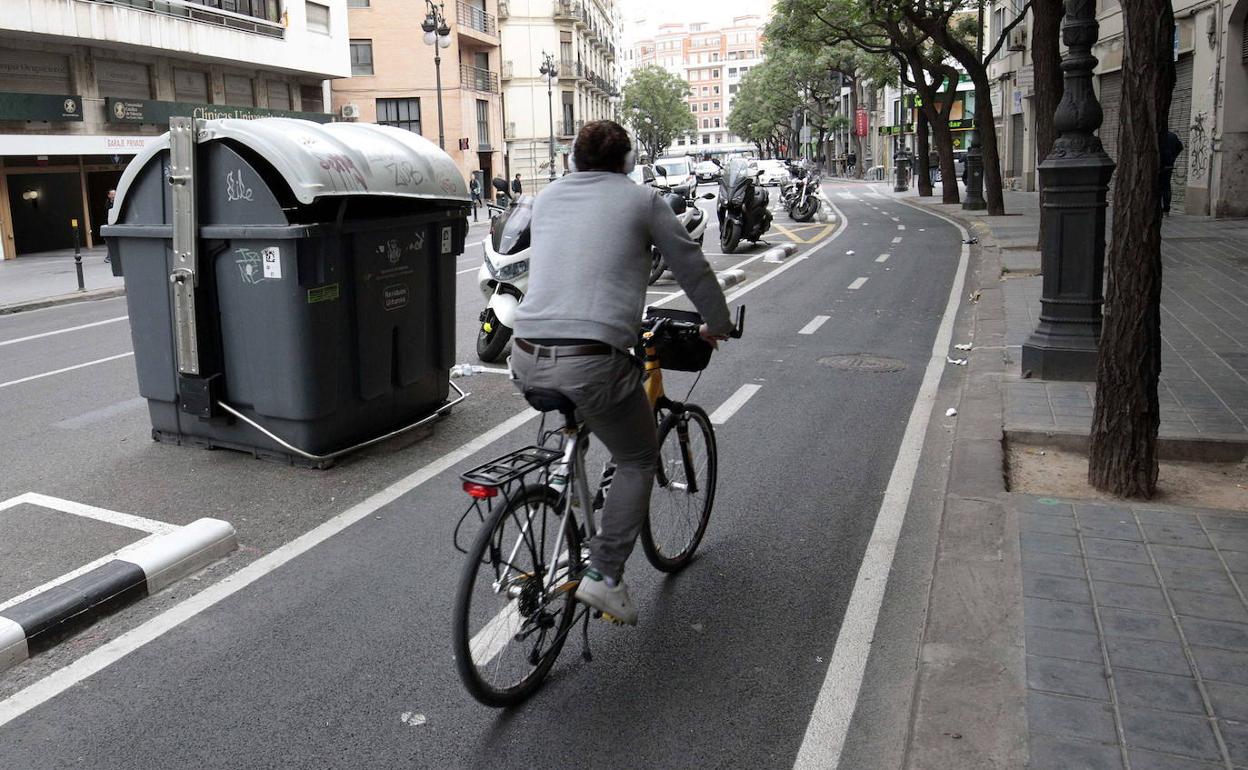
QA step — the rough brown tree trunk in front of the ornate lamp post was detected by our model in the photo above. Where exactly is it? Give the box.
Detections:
[1088,0,1174,498]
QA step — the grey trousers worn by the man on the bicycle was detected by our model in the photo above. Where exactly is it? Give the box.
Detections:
[512,347,659,579]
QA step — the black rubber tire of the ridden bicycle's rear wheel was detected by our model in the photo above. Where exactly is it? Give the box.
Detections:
[452,484,582,708]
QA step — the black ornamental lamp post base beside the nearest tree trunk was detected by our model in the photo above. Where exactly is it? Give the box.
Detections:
[1022,0,1114,381]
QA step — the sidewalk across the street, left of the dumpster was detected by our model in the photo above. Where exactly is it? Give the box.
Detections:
[0,246,124,313]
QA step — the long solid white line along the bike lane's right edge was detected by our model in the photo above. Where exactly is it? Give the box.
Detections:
[794,192,971,770]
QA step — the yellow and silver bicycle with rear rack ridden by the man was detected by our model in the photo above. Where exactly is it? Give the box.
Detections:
[453,307,745,706]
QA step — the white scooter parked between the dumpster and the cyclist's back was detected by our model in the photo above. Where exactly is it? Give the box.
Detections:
[477,195,533,363]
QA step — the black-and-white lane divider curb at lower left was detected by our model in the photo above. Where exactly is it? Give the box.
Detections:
[0,519,238,671]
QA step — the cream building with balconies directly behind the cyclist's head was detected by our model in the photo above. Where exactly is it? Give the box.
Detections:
[502,0,623,191]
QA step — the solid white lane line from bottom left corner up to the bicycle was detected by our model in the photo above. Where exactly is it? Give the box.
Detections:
[0,409,538,726]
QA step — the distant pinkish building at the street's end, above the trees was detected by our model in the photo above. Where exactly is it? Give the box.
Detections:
[626,16,763,156]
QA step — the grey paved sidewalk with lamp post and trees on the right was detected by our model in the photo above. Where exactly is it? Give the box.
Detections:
[893,182,1248,770]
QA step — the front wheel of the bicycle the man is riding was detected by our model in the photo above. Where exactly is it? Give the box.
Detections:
[641,404,718,573]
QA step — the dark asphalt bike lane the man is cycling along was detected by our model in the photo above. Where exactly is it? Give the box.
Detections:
[0,185,958,768]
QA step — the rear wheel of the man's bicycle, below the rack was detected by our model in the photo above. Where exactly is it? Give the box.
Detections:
[453,484,582,706]
